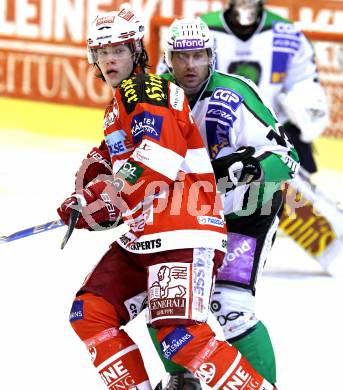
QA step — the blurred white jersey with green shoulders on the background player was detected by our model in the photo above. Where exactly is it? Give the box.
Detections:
[201,10,318,123]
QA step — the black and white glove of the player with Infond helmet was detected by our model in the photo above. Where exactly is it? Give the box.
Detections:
[212,146,262,187]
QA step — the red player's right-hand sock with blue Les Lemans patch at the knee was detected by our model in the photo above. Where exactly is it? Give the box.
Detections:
[157,323,275,390]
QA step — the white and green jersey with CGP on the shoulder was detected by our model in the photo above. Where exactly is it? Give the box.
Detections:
[162,71,298,217]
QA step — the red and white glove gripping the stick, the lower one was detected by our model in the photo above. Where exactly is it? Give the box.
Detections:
[57,181,121,229]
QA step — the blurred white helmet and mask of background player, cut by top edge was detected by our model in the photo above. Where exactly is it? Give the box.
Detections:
[229,0,264,26]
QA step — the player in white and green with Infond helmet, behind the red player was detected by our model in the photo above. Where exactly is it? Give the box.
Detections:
[150,18,298,390]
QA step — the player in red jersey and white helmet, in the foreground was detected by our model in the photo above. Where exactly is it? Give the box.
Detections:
[58,9,274,390]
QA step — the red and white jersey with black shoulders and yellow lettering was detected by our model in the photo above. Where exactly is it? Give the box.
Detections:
[104,74,227,253]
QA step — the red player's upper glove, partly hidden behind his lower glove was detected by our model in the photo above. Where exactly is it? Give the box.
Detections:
[75,141,112,191]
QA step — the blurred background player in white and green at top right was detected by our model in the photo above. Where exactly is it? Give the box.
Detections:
[201,0,329,173]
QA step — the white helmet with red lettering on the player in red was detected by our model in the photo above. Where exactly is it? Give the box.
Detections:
[87,8,144,64]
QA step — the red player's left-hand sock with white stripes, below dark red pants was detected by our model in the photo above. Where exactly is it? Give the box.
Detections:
[70,293,151,390]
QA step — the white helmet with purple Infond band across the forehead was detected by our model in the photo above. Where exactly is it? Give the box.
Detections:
[164,18,215,70]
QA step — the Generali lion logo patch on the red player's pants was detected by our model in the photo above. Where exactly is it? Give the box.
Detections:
[149,263,191,322]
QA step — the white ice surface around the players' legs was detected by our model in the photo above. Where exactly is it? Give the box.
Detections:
[0,132,343,390]
